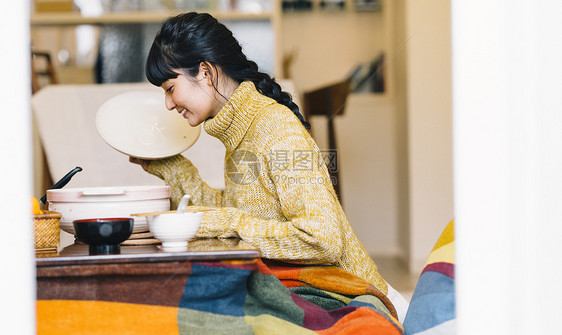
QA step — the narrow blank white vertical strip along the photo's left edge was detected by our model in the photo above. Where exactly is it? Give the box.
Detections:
[0,1,35,334]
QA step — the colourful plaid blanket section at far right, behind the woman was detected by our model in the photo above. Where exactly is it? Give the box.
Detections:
[404,221,456,335]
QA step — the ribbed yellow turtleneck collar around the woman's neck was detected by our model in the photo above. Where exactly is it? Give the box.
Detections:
[204,81,275,151]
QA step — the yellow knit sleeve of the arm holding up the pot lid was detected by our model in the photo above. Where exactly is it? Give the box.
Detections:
[148,155,222,209]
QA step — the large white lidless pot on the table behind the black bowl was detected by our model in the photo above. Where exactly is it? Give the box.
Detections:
[47,186,170,235]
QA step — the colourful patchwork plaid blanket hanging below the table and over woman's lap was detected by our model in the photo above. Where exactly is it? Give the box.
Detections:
[37,260,404,335]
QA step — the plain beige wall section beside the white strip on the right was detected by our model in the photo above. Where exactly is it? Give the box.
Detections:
[406,0,454,273]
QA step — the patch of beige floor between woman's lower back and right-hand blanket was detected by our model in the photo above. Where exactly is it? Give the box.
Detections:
[373,256,419,301]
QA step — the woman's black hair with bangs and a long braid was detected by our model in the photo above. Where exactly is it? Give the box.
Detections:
[146,12,310,130]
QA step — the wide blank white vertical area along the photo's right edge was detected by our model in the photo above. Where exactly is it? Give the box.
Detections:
[451,0,562,334]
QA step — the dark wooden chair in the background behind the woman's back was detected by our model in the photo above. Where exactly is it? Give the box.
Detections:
[303,78,351,201]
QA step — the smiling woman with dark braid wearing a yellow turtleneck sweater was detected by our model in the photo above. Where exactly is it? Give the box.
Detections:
[131,13,388,294]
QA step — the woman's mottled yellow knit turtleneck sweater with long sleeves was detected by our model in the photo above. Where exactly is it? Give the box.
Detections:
[148,82,387,294]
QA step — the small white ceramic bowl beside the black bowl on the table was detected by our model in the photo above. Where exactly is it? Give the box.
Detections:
[146,212,203,252]
